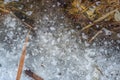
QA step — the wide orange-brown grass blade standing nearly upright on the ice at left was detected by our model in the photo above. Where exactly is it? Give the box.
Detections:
[16,31,30,80]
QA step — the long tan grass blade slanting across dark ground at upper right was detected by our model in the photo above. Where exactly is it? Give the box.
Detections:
[81,9,117,31]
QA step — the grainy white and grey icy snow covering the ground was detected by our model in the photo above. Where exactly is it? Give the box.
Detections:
[0,0,120,80]
